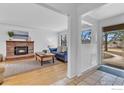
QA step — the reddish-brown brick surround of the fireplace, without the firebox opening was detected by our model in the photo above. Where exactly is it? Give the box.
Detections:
[6,40,34,60]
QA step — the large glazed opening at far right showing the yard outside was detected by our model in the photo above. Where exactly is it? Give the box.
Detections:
[102,24,124,69]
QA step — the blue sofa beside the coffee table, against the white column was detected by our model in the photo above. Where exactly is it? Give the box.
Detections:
[49,48,68,62]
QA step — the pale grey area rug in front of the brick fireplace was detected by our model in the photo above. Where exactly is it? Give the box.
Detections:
[4,61,60,77]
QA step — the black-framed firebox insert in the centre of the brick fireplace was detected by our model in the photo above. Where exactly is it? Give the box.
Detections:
[14,46,28,55]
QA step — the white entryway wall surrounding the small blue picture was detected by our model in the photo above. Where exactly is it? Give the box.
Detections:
[77,16,98,76]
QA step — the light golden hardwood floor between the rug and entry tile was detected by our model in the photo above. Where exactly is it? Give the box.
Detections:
[3,58,67,85]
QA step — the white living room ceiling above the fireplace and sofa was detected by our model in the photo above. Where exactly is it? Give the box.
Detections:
[0,3,67,32]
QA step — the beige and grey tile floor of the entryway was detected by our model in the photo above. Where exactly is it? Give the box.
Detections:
[54,70,124,85]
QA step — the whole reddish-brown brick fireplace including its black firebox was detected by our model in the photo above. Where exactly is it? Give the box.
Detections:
[6,41,34,60]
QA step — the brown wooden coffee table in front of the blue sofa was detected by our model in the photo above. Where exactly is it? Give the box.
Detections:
[35,52,55,66]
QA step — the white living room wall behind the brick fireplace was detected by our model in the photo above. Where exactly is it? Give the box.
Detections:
[0,25,57,56]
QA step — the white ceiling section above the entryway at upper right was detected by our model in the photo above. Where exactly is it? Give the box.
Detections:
[88,3,124,20]
